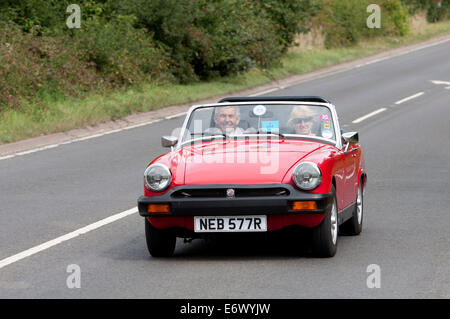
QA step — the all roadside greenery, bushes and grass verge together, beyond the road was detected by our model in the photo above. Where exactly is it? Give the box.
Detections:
[0,0,450,143]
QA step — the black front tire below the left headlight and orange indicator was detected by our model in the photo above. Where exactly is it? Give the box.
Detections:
[145,218,177,257]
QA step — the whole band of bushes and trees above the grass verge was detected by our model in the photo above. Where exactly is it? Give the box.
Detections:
[0,0,450,110]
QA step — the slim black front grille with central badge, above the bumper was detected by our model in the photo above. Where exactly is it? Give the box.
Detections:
[172,187,290,198]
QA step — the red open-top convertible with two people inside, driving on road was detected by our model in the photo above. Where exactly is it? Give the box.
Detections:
[138,96,367,257]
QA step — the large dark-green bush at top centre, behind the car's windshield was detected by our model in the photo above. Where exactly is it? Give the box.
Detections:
[121,0,282,82]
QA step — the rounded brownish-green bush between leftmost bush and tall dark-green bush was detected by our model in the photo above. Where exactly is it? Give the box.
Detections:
[73,16,170,87]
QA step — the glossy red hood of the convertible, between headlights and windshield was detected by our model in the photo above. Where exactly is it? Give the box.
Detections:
[183,139,324,185]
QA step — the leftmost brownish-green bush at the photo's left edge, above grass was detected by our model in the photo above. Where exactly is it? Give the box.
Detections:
[0,24,100,107]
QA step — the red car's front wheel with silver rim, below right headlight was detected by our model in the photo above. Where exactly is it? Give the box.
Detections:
[312,186,339,257]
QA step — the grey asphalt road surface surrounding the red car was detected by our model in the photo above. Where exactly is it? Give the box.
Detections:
[0,41,450,298]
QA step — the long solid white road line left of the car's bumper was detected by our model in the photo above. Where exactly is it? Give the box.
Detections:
[0,207,138,269]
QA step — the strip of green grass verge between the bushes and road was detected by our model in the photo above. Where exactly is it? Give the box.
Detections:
[0,20,450,143]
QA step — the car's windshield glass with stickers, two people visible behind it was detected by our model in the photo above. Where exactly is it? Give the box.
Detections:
[182,104,336,144]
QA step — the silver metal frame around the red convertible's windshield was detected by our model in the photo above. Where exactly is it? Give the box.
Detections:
[175,101,342,150]
